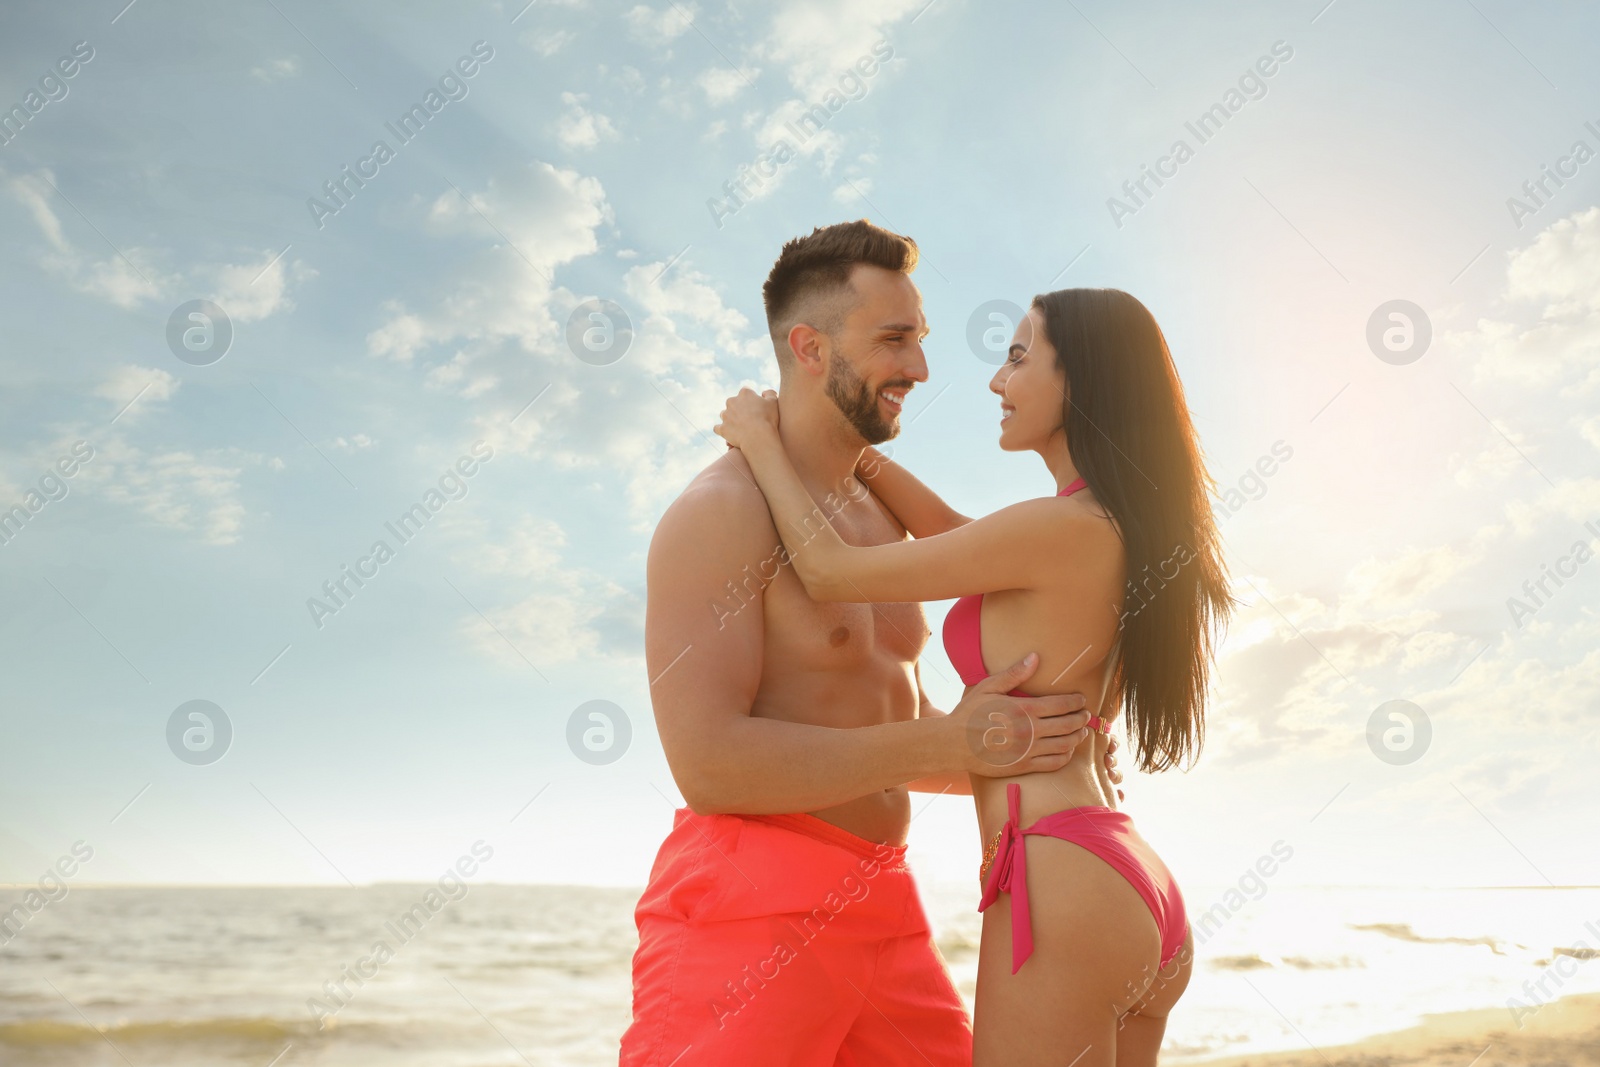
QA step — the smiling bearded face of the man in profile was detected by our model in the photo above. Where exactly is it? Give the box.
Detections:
[827,264,928,445]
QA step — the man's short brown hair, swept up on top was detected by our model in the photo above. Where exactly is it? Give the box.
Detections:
[762,219,917,368]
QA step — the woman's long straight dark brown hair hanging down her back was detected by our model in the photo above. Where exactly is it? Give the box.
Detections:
[1034,290,1234,771]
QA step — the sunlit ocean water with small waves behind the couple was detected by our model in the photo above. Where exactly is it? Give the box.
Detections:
[0,883,1600,1067]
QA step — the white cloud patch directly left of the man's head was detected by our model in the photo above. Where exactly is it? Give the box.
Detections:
[368,163,776,526]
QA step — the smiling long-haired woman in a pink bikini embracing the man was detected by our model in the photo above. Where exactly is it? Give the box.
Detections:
[717,290,1232,1067]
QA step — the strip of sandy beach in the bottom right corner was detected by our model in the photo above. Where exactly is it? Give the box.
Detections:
[1203,995,1600,1067]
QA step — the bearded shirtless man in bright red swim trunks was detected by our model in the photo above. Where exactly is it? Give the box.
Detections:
[621,221,1113,1067]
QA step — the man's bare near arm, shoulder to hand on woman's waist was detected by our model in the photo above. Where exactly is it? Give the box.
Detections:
[645,454,1086,814]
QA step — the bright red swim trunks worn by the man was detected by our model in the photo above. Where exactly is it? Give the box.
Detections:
[621,808,973,1067]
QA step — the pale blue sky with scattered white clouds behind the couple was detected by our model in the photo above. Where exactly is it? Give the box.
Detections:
[0,0,1600,886]
